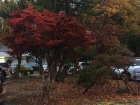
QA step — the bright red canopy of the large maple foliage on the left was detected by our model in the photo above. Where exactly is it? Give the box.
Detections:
[1,3,94,59]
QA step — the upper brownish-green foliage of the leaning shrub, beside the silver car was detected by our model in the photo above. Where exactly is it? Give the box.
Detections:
[93,44,134,70]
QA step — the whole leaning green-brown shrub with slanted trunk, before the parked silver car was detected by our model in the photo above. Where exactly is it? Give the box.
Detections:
[75,44,134,94]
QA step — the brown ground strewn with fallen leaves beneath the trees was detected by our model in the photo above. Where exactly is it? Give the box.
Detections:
[0,75,140,105]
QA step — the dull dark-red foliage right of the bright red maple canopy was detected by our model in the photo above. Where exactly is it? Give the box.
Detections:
[90,26,121,53]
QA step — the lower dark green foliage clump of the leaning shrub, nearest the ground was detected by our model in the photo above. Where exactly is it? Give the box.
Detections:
[74,66,113,87]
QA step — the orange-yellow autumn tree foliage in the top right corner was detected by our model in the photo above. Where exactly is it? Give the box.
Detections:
[92,0,140,35]
